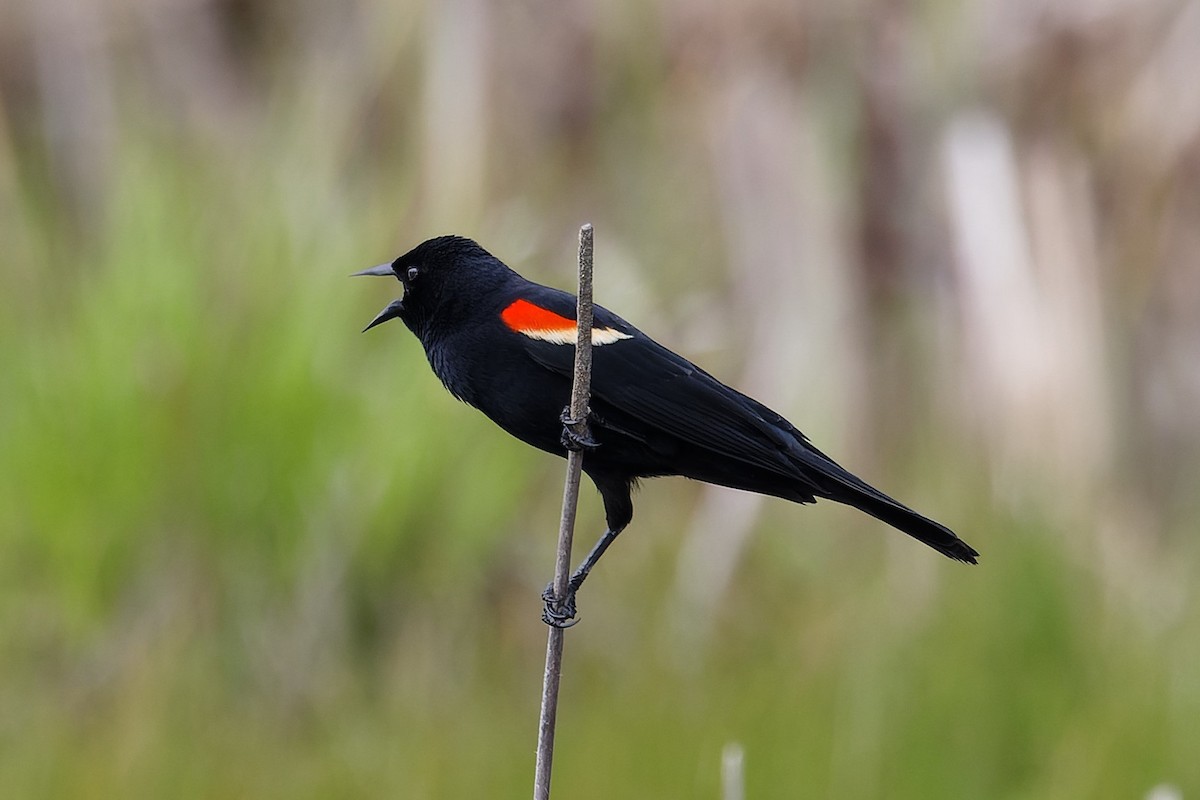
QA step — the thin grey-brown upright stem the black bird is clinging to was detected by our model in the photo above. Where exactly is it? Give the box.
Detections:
[533,224,592,800]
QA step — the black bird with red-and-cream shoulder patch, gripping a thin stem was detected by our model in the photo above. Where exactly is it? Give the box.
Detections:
[356,236,978,626]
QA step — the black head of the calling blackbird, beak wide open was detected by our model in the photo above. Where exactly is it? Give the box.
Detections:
[354,236,514,339]
